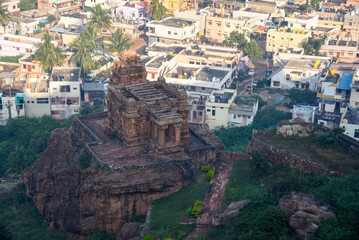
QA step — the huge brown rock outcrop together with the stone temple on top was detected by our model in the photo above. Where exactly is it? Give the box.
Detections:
[22,53,221,235]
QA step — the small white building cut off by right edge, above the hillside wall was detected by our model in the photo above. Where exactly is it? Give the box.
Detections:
[340,107,359,141]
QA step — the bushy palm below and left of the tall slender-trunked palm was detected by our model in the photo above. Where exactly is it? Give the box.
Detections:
[70,28,97,76]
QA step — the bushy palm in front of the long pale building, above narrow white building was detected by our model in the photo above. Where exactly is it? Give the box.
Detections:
[35,33,66,72]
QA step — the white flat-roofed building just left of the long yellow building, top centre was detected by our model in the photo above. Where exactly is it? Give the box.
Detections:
[146,17,199,44]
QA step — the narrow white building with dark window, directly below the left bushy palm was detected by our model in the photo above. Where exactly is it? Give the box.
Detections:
[49,67,82,119]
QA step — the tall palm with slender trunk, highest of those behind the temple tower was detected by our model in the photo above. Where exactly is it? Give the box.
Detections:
[87,4,112,56]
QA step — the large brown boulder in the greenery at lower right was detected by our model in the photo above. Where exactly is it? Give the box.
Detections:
[278,193,336,239]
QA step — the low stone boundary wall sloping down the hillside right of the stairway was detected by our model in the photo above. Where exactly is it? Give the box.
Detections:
[246,135,333,174]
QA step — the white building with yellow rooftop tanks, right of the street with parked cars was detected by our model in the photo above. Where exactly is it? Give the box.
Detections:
[271,55,331,91]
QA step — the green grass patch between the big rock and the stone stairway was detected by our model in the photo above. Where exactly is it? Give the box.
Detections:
[149,174,209,239]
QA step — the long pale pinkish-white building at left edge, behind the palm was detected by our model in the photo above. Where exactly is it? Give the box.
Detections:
[0,33,57,56]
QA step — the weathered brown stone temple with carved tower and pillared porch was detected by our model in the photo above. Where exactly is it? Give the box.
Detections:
[107,51,189,153]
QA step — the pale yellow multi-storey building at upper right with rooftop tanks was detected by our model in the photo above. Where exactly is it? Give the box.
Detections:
[266,28,312,52]
